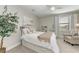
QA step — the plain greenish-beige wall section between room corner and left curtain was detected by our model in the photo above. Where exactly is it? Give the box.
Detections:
[38,15,54,31]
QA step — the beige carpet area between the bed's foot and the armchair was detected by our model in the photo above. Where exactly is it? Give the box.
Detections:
[58,39,79,53]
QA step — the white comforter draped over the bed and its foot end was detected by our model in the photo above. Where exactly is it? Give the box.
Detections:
[22,32,59,52]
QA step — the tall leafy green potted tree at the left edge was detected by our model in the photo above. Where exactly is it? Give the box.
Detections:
[0,6,18,53]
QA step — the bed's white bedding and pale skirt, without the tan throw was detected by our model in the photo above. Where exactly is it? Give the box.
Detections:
[21,24,59,53]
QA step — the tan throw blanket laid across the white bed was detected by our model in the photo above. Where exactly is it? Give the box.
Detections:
[38,32,52,42]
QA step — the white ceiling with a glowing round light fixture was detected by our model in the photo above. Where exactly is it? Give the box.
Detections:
[21,5,79,17]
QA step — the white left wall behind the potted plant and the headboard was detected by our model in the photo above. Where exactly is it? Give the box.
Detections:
[0,6,37,50]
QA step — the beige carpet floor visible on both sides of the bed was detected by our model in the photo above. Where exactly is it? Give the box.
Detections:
[7,39,79,53]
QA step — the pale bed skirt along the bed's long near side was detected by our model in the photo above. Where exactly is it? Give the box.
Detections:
[22,40,53,53]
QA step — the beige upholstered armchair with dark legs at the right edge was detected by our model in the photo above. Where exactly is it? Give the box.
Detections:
[64,32,79,46]
